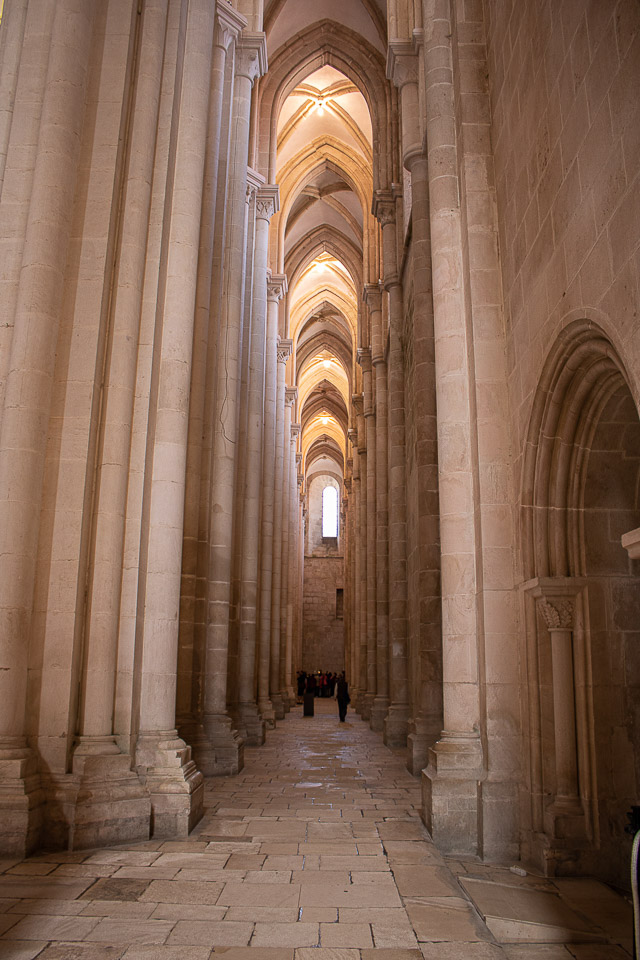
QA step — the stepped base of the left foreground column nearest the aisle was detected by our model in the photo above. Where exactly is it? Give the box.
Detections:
[136,730,204,837]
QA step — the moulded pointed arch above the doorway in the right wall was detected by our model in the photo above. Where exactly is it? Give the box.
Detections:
[520,319,629,581]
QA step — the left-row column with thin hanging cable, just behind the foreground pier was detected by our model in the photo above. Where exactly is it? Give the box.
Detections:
[197,33,267,775]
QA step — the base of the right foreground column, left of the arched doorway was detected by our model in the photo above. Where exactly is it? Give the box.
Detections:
[422,733,485,857]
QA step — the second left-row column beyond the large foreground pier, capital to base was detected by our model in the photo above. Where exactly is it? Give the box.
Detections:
[232,186,279,745]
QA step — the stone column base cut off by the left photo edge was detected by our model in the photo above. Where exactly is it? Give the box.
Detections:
[0,738,44,859]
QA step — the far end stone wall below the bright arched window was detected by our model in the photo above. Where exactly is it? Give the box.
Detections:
[302,556,345,672]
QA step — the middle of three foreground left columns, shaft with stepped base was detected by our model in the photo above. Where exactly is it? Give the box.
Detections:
[72,0,180,846]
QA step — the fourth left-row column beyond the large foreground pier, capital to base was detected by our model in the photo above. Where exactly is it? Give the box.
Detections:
[269,340,293,720]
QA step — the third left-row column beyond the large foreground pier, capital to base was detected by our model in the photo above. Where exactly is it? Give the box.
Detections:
[258,274,287,727]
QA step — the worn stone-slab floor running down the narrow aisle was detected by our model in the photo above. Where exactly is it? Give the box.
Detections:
[0,701,632,960]
